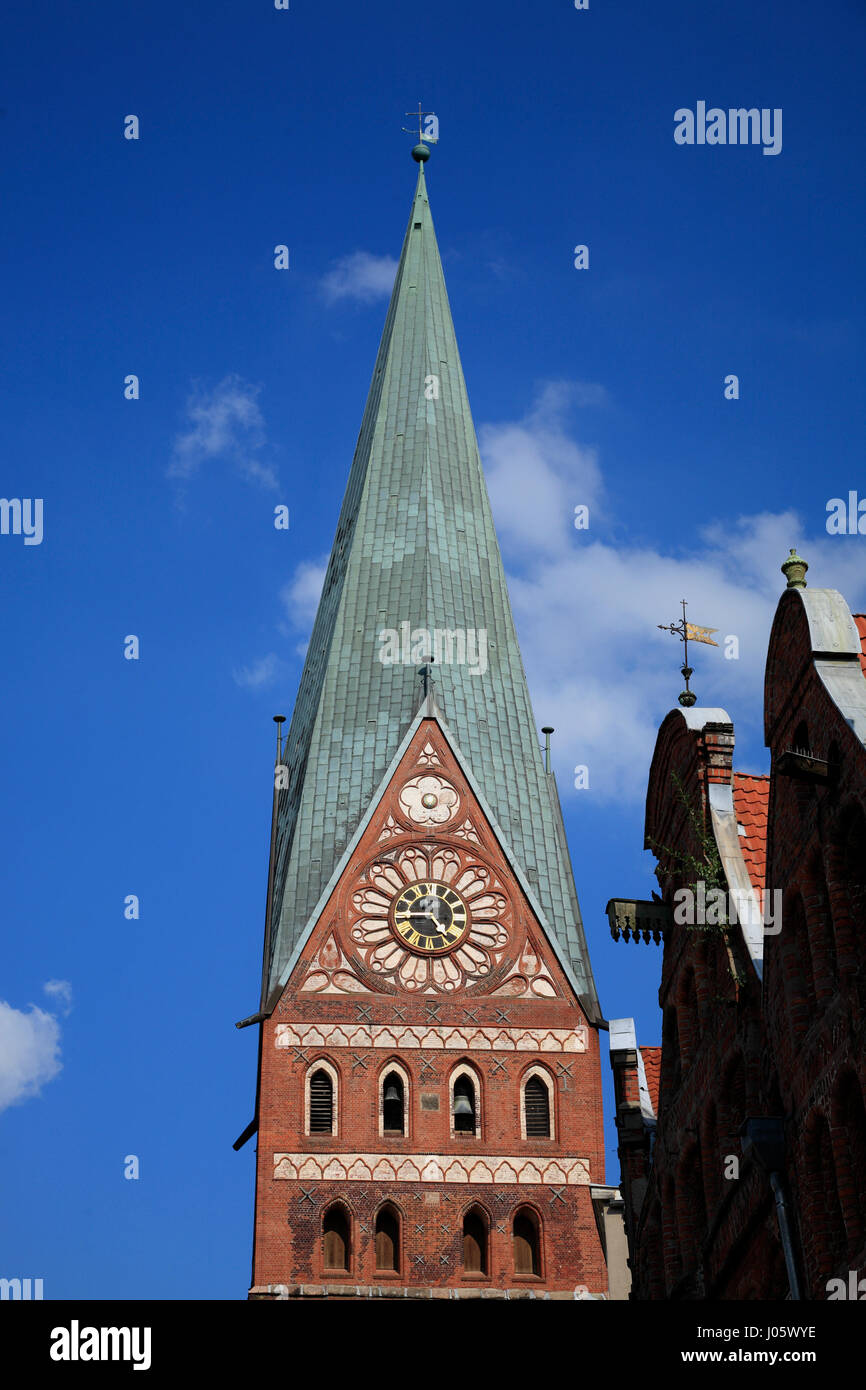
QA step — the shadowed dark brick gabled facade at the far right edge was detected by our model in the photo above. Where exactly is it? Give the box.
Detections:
[765,589,866,1298]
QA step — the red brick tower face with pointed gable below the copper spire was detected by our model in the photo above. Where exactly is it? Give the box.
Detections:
[252,717,607,1297]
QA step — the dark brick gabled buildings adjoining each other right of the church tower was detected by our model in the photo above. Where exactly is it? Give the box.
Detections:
[609,553,866,1300]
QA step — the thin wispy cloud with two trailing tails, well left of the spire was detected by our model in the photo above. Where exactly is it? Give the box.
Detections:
[167,373,279,491]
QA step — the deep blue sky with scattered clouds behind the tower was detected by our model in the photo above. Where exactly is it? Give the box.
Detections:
[0,0,866,1298]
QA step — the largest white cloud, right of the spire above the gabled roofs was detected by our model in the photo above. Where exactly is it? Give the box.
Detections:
[480,384,866,801]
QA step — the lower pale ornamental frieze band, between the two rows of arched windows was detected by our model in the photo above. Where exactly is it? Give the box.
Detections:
[274,1154,589,1187]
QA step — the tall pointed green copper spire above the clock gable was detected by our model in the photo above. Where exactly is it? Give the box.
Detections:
[263,145,598,1008]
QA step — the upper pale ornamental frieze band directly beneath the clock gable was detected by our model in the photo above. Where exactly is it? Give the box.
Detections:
[275,1023,587,1052]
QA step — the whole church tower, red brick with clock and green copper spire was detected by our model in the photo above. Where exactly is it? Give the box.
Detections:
[239,145,607,1298]
